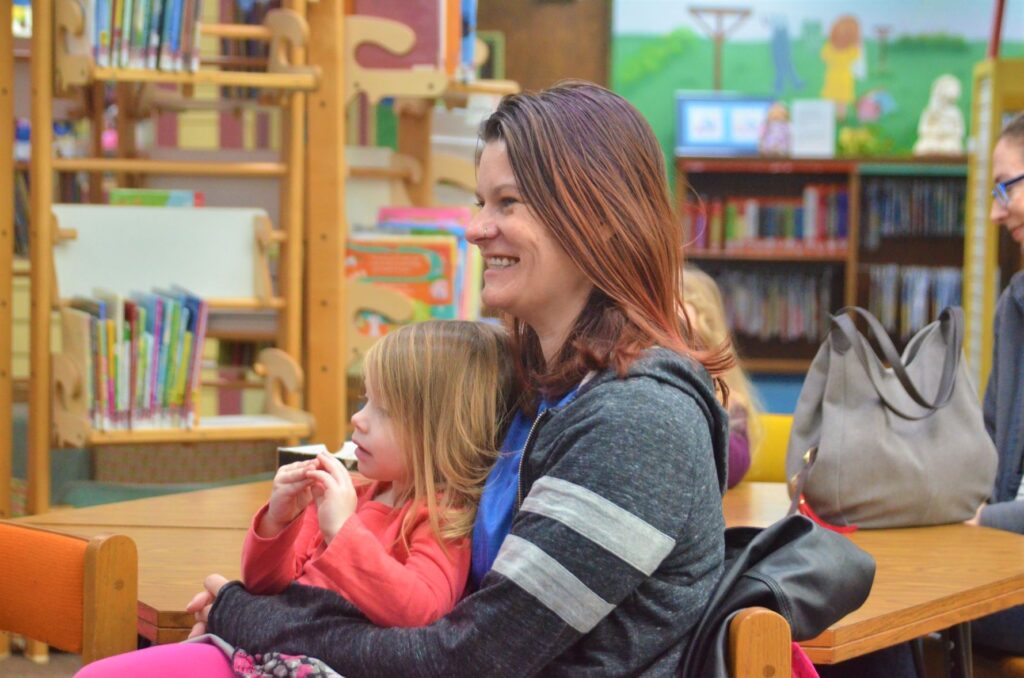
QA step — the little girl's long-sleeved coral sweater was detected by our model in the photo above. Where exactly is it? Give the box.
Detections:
[242,482,470,627]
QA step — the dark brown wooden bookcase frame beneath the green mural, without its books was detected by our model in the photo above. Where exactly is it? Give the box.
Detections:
[675,157,967,374]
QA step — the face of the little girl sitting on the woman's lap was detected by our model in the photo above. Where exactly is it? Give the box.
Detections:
[352,380,409,484]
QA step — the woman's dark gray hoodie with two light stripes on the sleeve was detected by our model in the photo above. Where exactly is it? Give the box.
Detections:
[209,349,728,676]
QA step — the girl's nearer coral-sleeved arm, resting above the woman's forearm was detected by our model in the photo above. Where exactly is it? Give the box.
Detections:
[296,510,470,627]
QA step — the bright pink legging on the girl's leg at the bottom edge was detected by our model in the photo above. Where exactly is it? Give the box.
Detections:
[75,643,234,678]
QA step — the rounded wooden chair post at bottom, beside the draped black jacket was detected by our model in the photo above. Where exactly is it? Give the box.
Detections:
[729,607,793,678]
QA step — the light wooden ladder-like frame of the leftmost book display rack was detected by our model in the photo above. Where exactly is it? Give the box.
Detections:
[20,0,319,512]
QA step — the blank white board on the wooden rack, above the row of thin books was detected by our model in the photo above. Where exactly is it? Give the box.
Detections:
[53,205,269,299]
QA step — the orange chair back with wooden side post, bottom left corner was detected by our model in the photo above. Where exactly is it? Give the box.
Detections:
[0,521,138,664]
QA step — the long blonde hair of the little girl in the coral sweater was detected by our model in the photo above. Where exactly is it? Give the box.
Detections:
[364,321,514,546]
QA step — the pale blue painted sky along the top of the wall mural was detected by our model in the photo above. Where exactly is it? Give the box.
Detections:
[611,0,1024,42]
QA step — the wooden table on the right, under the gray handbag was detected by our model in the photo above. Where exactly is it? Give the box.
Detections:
[723,482,1024,664]
